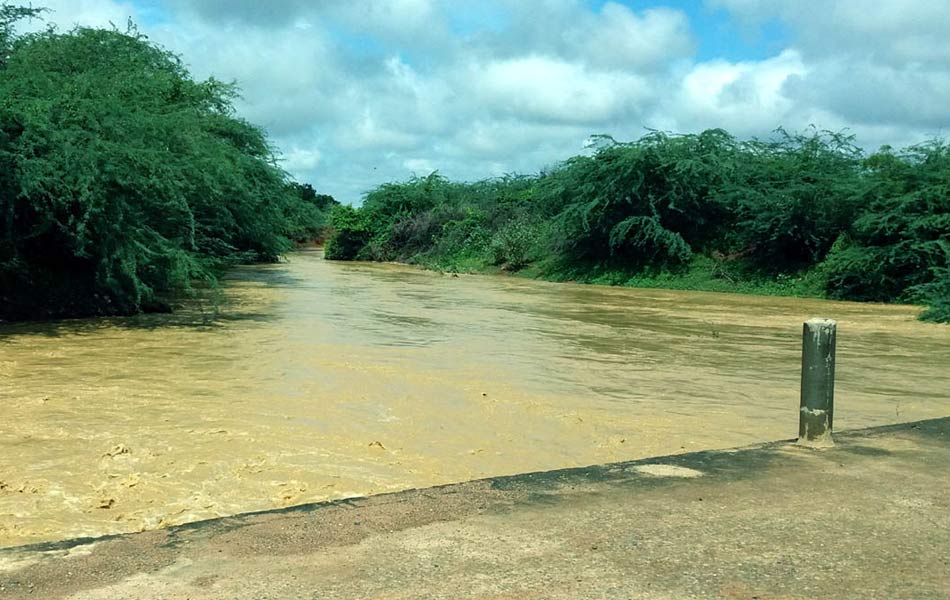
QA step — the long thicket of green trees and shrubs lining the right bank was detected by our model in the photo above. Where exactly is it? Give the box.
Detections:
[331,130,950,321]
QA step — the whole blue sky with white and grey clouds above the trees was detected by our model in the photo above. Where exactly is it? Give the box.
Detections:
[16,0,950,203]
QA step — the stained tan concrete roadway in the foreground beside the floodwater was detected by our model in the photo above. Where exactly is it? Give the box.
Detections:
[0,418,950,600]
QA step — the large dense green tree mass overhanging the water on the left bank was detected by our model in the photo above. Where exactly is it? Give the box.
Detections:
[0,12,330,318]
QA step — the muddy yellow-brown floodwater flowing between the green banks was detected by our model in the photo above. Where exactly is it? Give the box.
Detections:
[0,252,950,546]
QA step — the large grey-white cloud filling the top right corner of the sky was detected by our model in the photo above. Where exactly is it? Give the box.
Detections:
[710,0,950,147]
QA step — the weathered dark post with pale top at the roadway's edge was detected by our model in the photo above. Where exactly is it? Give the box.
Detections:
[798,319,838,446]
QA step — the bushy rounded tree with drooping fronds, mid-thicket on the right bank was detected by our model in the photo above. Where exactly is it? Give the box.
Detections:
[539,130,736,268]
